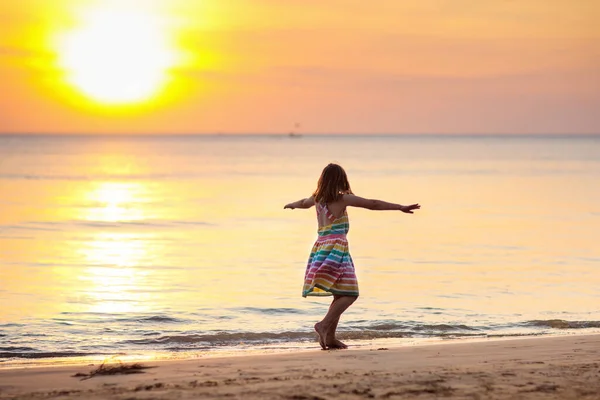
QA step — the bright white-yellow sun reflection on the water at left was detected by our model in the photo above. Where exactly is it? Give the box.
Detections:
[76,178,153,313]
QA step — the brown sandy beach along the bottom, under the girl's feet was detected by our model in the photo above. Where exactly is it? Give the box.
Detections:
[0,335,600,400]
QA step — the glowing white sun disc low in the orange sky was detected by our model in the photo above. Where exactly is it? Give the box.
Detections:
[57,9,177,104]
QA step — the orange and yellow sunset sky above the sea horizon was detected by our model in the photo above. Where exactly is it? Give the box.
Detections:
[0,0,600,134]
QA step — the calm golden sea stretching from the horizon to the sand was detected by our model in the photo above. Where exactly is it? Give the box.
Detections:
[0,135,600,368]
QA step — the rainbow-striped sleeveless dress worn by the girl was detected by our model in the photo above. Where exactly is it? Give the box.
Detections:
[302,203,358,297]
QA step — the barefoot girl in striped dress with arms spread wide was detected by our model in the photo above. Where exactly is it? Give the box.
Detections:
[284,164,421,350]
